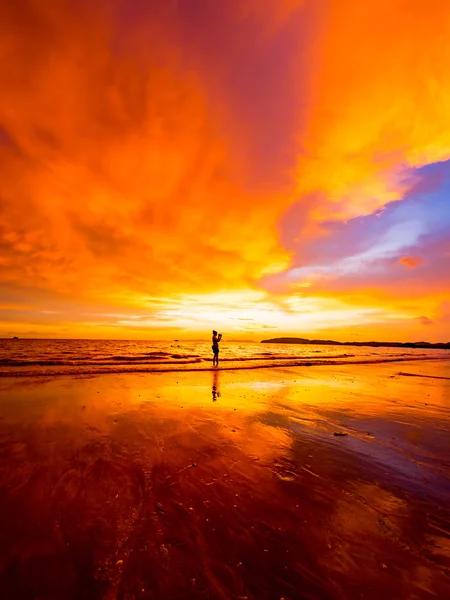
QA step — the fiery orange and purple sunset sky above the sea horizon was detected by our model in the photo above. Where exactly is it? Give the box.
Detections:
[0,0,450,342]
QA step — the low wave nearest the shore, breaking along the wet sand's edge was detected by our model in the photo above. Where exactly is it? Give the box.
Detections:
[0,355,450,377]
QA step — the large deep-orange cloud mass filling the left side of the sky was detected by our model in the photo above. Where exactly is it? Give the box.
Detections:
[0,0,294,310]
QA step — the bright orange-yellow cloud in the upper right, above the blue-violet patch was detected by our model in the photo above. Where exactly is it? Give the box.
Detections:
[296,0,450,227]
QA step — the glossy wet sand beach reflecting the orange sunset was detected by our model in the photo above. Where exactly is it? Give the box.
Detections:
[0,361,450,600]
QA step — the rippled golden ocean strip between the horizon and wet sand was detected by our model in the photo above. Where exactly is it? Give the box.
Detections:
[0,339,450,377]
